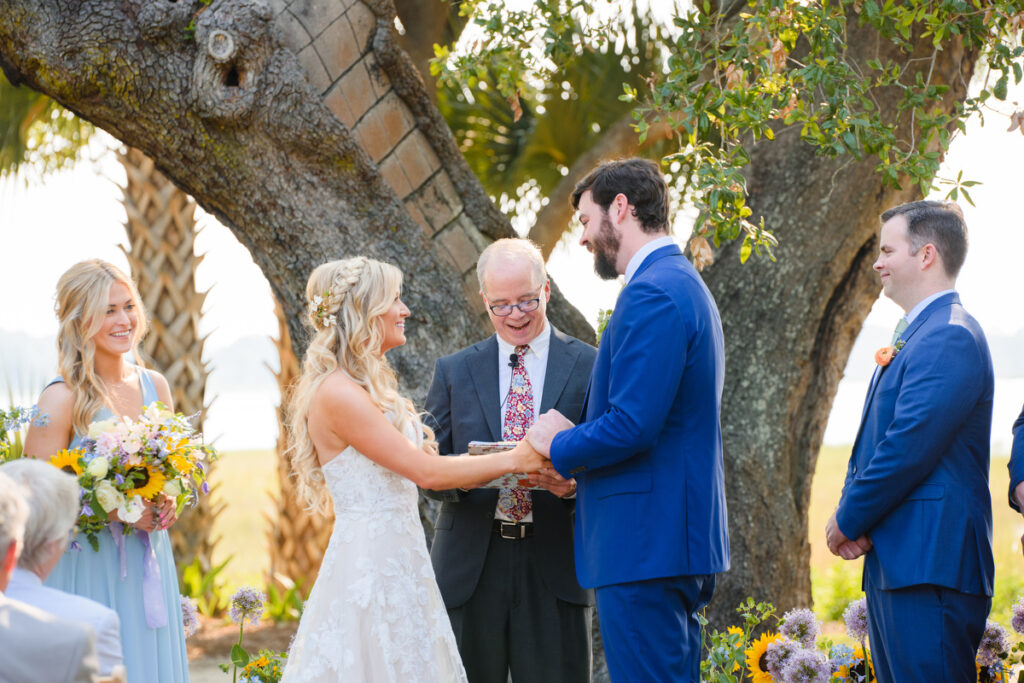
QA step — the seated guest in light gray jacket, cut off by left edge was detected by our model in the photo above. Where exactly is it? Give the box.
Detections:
[0,472,96,683]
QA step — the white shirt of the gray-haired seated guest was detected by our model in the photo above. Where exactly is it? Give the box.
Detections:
[4,565,124,676]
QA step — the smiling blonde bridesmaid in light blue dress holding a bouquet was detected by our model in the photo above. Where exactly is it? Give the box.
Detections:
[25,260,188,683]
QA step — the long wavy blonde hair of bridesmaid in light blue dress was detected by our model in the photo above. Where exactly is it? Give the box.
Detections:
[54,259,148,434]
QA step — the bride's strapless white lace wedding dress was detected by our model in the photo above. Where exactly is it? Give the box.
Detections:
[282,425,466,683]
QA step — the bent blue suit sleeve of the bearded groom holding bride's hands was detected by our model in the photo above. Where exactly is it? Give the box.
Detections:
[551,282,695,477]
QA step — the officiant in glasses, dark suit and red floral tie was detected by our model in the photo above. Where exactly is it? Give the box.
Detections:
[425,240,596,683]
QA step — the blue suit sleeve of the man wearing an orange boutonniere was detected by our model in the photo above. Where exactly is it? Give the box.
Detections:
[836,325,987,539]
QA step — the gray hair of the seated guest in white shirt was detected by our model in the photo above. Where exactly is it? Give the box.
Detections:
[0,458,79,571]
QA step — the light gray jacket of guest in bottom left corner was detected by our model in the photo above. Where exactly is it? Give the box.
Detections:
[0,593,97,683]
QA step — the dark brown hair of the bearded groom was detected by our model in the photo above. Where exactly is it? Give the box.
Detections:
[572,158,669,232]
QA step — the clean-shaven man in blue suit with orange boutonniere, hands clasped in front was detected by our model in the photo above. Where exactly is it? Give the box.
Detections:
[825,202,994,683]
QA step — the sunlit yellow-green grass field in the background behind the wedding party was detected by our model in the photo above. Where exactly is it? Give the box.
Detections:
[210,446,1024,625]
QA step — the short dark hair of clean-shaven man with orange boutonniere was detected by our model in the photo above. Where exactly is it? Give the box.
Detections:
[882,200,967,278]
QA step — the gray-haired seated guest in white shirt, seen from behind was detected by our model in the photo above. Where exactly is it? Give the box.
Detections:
[0,458,124,674]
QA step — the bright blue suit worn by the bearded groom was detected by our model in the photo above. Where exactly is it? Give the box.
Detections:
[551,244,729,683]
